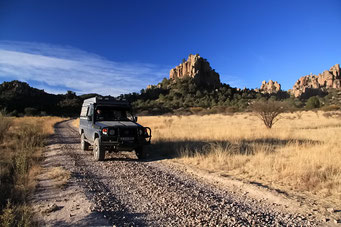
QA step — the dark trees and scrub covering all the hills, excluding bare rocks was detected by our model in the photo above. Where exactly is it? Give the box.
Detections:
[0,77,341,117]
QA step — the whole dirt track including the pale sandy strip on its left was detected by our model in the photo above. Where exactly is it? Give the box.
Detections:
[32,121,321,226]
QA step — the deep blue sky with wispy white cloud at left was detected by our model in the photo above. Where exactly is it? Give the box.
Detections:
[0,0,341,95]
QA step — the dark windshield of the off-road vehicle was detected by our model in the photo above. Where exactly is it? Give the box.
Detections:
[95,106,133,121]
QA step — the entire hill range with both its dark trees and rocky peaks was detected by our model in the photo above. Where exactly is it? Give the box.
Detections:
[0,54,341,116]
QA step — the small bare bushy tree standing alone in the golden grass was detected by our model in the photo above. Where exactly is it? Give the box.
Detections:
[251,100,287,128]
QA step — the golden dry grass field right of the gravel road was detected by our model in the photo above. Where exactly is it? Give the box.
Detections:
[139,111,341,207]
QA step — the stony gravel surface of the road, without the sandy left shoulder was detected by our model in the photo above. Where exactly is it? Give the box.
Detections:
[31,121,321,226]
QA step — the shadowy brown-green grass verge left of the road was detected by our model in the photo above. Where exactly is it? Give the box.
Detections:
[0,116,62,226]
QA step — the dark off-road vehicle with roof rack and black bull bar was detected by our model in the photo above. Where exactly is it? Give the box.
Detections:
[79,96,151,161]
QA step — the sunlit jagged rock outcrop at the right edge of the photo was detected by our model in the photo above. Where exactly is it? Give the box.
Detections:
[291,64,341,97]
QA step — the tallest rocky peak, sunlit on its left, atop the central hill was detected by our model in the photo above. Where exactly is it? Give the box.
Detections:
[169,54,220,87]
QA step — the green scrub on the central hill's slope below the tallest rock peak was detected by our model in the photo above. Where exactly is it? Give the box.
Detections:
[121,77,295,114]
